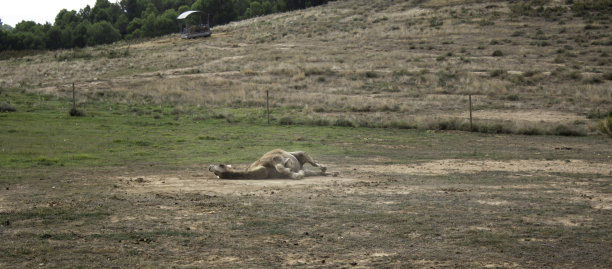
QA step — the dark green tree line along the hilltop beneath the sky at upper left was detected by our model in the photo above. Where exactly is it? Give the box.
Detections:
[0,0,329,51]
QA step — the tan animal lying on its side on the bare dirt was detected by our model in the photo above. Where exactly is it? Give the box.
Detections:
[208,149,329,179]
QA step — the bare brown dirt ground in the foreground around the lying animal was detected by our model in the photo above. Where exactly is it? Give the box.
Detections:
[0,153,612,268]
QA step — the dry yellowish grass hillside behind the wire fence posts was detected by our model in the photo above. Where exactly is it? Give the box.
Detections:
[0,1,612,133]
